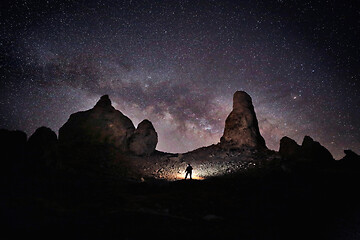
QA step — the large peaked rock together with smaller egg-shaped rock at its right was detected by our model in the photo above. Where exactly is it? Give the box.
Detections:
[59,95,158,168]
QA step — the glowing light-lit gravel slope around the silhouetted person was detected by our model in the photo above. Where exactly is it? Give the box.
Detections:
[127,142,280,180]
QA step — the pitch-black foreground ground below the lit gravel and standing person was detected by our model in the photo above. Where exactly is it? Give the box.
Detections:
[0,165,360,239]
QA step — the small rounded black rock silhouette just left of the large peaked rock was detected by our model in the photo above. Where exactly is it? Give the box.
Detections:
[27,127,58,166]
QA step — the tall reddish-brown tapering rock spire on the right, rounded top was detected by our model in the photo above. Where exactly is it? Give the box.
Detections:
[220,91,266,148]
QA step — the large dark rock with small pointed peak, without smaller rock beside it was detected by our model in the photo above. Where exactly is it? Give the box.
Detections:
[59,95,135,166]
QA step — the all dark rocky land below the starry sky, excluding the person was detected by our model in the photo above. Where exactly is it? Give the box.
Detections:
[0,91,360,240]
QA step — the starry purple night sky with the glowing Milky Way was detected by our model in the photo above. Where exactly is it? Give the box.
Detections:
[0,0,360,158]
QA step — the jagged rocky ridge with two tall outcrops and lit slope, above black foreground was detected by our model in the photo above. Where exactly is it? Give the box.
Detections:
[0,91,360,179]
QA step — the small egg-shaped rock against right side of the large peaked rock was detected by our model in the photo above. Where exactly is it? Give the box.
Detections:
[129,119,158,156]
